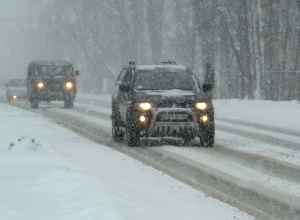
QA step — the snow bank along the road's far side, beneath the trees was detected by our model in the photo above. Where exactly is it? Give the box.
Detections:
[75,93,300,131]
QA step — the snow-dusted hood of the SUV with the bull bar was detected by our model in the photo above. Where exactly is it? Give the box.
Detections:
[136,89,211,107]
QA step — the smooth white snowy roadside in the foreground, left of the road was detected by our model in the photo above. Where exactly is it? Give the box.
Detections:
[0,104,253,220]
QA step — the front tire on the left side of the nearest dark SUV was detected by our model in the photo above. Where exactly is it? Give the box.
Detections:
[125,113,141,146]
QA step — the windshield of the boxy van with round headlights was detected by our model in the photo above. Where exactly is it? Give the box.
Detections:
[34,65,74,77]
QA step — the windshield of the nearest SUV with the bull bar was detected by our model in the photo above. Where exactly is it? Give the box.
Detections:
[135,70,199,90]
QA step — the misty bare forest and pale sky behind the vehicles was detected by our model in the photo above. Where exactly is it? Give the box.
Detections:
[0,0,300,100]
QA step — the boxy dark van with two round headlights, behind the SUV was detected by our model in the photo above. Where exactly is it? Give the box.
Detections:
[26,61,79,108]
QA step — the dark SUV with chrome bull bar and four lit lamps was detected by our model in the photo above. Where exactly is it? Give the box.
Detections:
[112,62,215,147]
